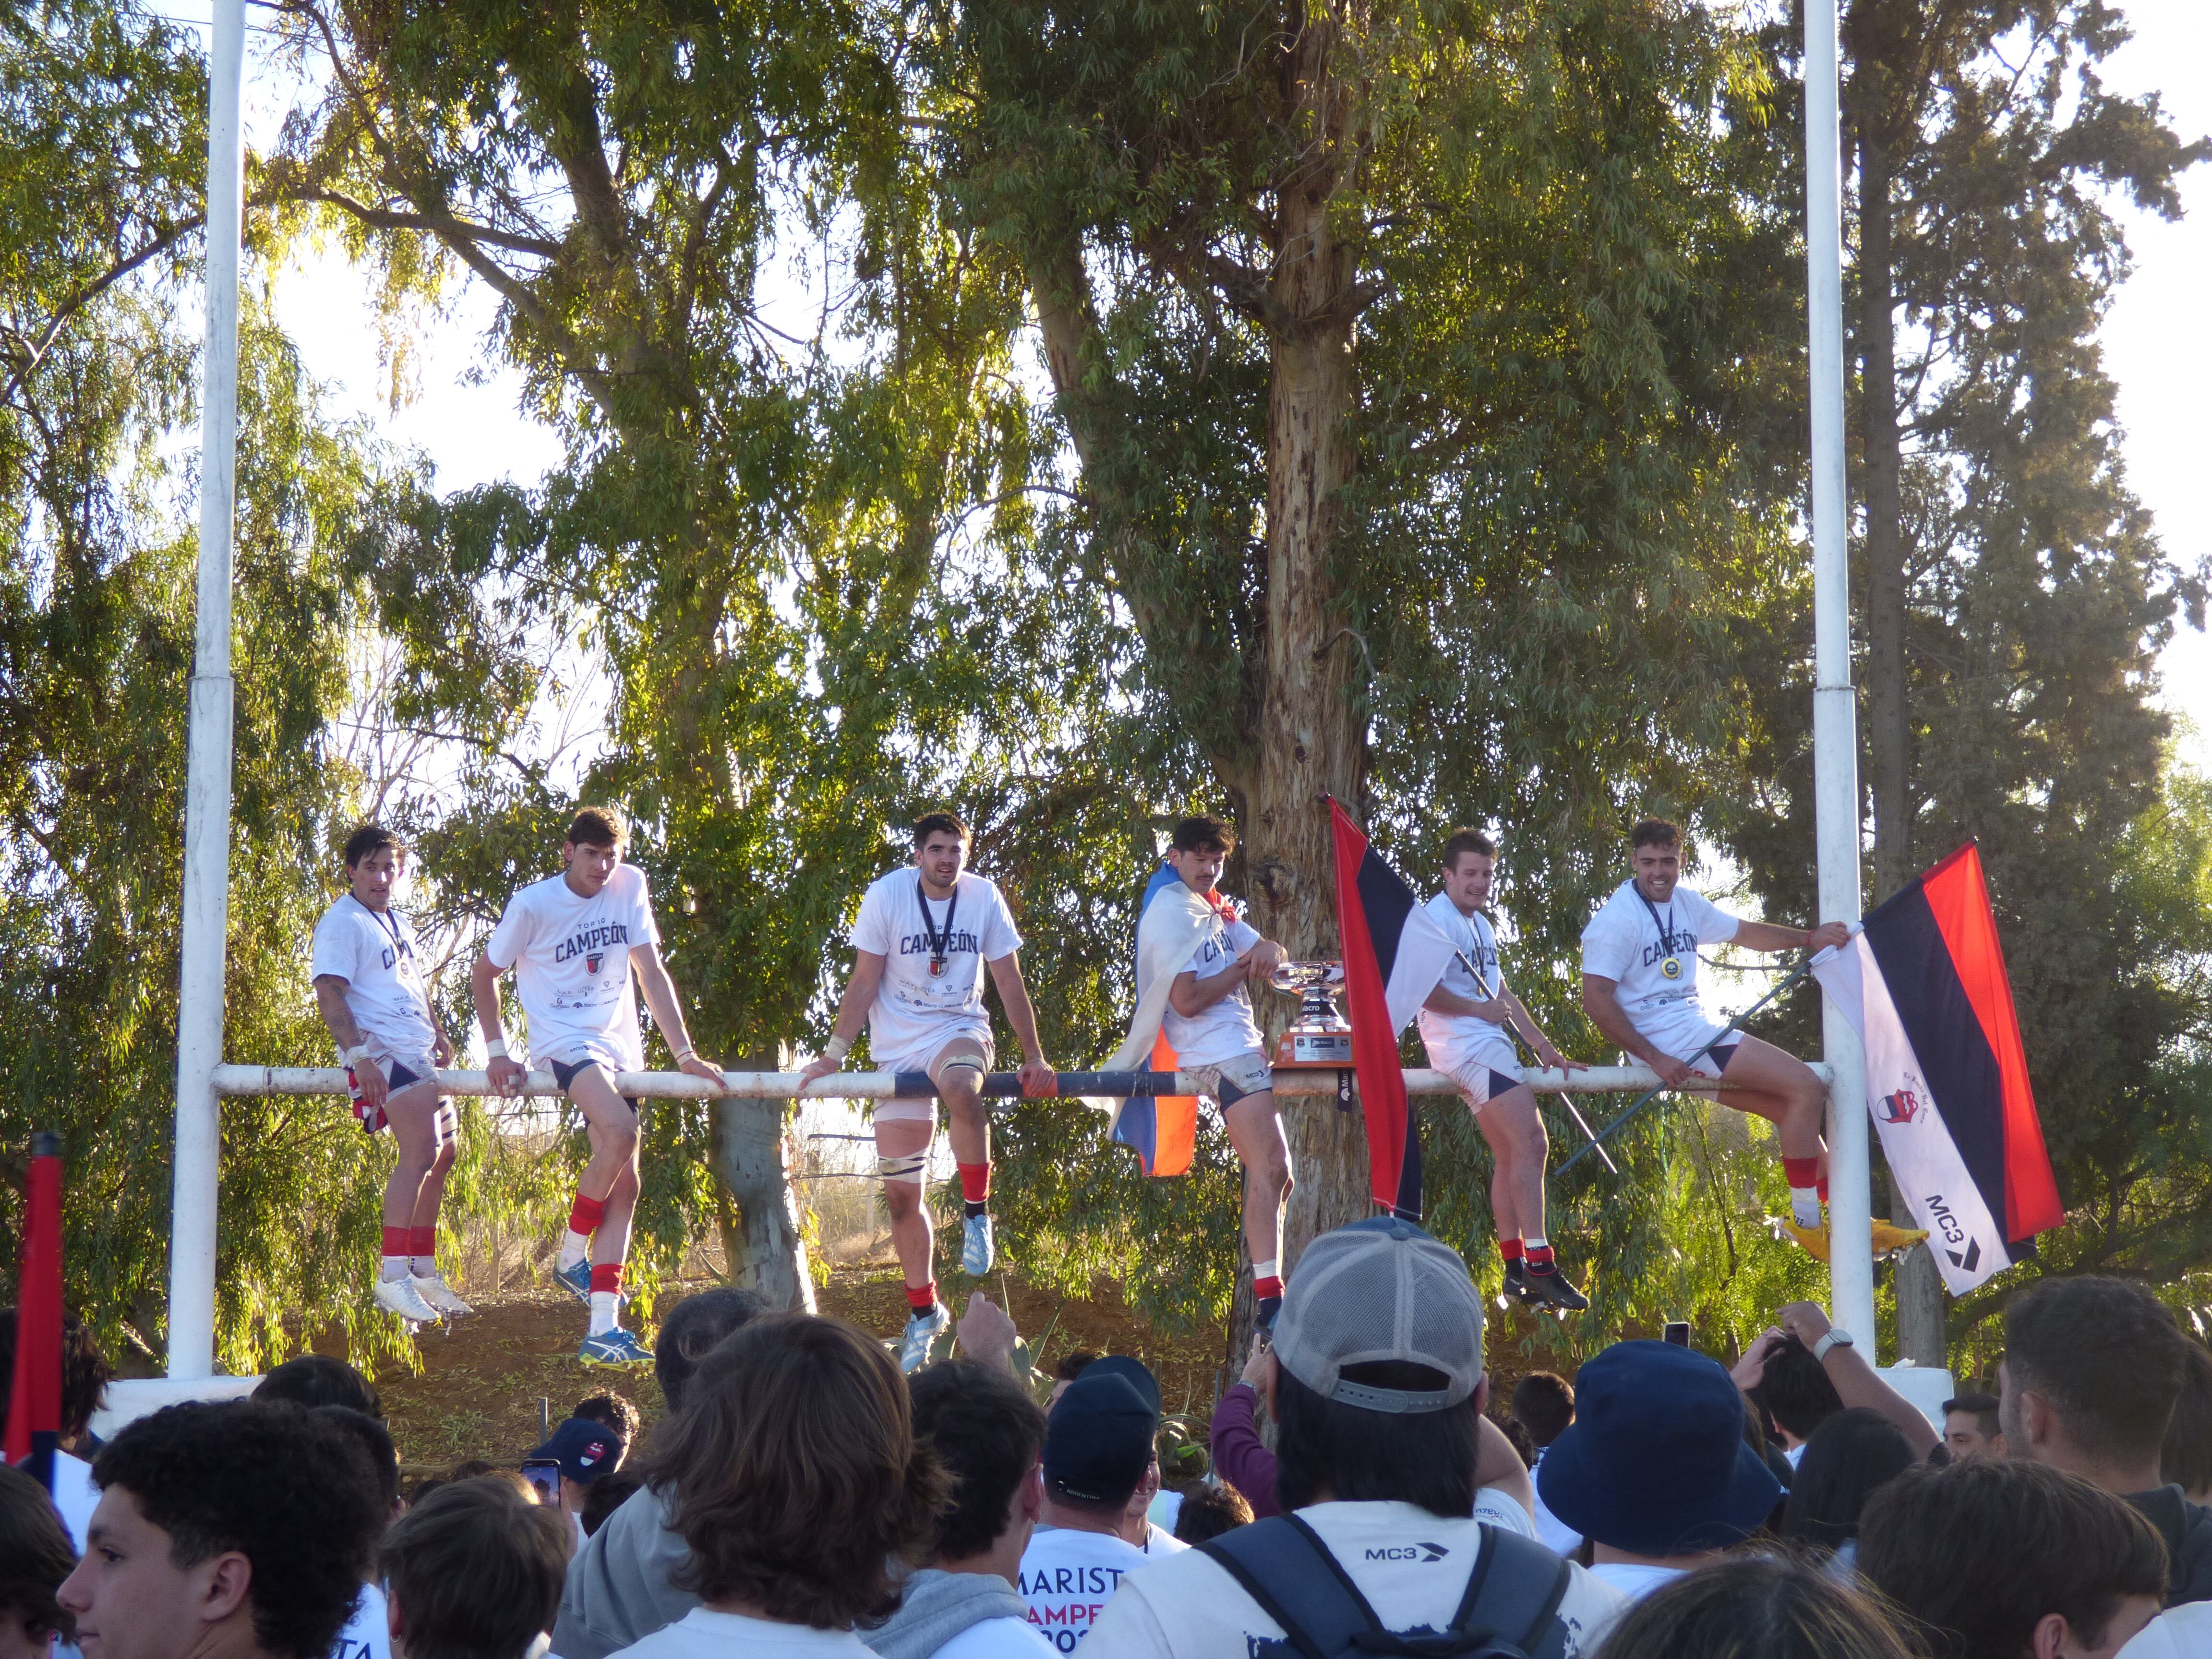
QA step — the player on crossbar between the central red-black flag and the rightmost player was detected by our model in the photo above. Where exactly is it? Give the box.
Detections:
[1420,830,1590,1312]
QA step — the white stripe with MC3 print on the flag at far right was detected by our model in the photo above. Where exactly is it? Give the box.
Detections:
[1812,934,2013,1296]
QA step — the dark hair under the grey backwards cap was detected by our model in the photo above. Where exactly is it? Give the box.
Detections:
[1274,1360,1482,1515]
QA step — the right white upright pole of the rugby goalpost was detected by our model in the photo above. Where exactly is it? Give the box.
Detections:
[1805,0,1874,1358]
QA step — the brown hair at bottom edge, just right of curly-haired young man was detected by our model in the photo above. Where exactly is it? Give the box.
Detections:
[376,1480,571,1659]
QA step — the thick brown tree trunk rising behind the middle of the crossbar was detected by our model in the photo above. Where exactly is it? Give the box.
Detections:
[1243,4,1374,1272]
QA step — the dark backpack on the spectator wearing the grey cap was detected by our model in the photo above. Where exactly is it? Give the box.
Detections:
[1199,1515,1573,1659]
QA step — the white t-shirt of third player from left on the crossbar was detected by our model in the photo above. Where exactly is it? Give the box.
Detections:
[852,867,1022,1070]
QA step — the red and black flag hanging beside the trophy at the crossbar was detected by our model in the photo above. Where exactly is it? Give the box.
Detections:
[1329,801,1458,1221]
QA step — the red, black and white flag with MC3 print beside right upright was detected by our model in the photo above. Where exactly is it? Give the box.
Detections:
[1812,843,2066,1296]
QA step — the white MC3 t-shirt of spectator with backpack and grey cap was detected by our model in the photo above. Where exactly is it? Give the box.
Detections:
[1084,1493,1626,1659]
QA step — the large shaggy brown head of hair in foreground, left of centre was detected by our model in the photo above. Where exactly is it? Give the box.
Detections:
[639,1314,947,1630]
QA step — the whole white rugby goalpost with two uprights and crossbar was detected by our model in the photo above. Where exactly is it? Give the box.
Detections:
[168,0,1874,1382]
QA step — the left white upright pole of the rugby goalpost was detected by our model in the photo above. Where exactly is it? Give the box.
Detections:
[168,0,245,1378]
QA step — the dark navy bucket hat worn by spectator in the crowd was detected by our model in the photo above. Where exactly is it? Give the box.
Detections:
[1535,1343,1783,1555]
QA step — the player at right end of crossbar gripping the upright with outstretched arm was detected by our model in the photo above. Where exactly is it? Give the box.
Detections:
[1582,818,1909,1261]
